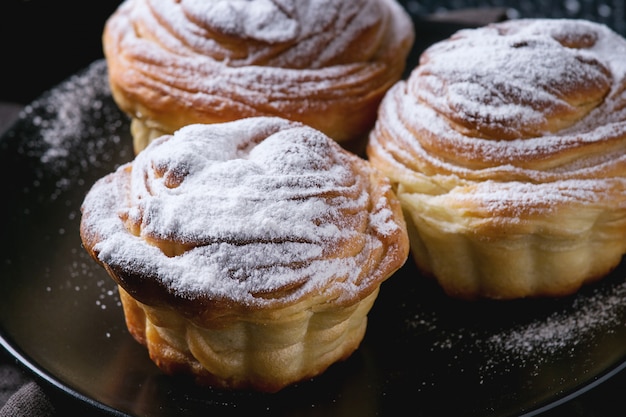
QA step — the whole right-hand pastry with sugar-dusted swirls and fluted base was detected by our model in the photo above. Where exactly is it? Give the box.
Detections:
[367,19,626,299]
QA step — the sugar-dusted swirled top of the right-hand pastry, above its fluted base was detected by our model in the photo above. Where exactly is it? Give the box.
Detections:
[368,19,626,212]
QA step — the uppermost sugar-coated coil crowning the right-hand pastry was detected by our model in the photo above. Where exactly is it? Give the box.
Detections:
[409,20,626,140]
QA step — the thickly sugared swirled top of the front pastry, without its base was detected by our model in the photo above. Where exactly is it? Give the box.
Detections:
[81,118,408,314]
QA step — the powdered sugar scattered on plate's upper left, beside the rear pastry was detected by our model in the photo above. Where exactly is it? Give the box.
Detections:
[20,60,131,185]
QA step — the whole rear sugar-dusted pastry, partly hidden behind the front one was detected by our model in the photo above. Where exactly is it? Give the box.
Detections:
[103,0,414,152]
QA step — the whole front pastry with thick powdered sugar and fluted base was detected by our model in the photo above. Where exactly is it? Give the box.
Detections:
[80,117,409,392]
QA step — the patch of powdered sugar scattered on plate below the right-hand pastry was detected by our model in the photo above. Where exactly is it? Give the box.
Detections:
[405,272,626,384]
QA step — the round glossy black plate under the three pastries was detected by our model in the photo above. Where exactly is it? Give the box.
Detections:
[0,55,626,417]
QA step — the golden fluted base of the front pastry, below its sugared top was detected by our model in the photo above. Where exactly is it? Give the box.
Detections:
[119,287,378,392]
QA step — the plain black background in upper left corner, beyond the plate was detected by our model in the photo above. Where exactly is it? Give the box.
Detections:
[0,0,120,104]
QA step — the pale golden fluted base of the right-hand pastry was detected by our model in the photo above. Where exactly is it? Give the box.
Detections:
[399,185,626,299]
